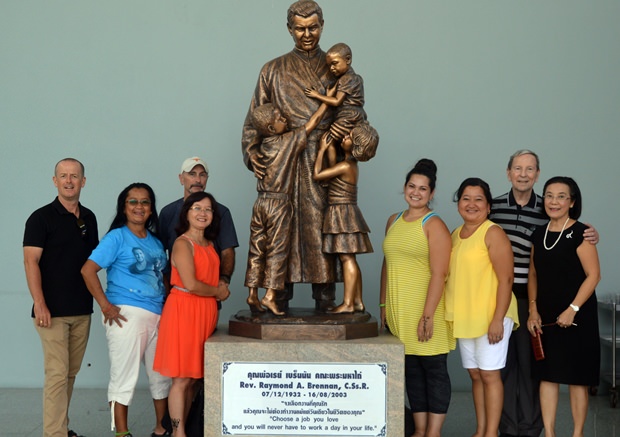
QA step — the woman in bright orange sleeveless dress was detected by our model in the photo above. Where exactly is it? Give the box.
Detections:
[153,192,230,437]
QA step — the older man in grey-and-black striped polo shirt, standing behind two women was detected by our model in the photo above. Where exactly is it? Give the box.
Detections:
[489,150,598,437]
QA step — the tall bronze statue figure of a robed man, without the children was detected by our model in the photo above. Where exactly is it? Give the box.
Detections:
[241,0,340,312]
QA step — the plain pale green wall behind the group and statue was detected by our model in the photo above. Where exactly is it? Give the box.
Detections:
[0,0,620,388]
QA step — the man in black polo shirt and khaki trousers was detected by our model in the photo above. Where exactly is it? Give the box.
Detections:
[23,158,99,437]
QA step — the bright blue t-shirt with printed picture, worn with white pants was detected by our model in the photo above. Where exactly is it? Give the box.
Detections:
[89,226,166,314]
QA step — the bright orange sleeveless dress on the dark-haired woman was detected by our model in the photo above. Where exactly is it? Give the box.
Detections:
[153,237,220,378]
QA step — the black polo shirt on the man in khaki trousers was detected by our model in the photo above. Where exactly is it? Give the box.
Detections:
[23,197,99,317]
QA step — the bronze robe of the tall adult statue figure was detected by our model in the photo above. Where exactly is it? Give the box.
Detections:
[241,47,341,284]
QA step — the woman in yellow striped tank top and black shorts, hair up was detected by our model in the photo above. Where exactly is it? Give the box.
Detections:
[380,159,455,437]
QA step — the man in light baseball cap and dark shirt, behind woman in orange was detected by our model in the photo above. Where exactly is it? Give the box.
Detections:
[159,156,239,290]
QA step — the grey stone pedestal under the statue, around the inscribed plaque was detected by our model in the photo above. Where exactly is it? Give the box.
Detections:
[204,326,405,437]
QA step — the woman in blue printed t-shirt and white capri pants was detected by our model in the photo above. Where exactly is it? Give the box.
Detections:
[82,183,170,437]
